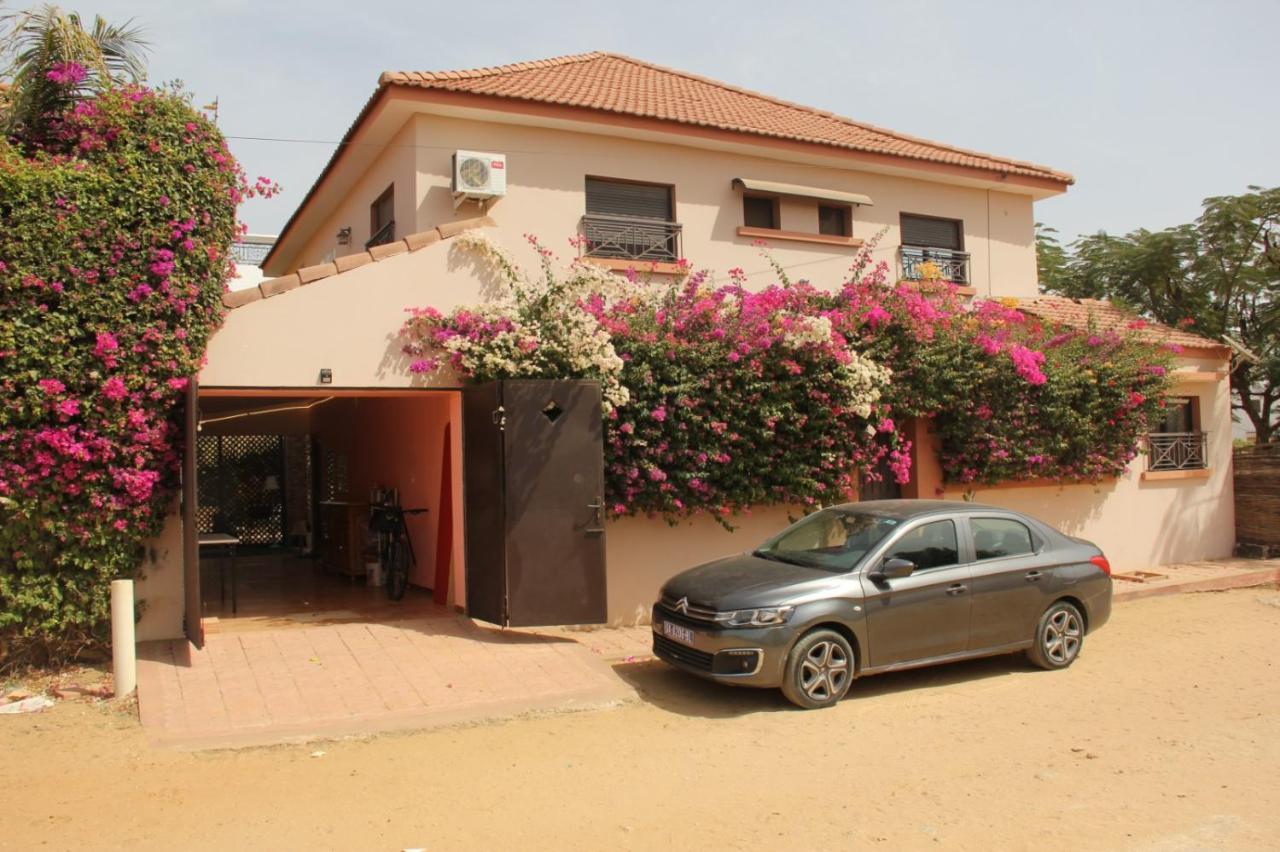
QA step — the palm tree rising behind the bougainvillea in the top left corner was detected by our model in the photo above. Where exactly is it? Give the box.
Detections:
[0,4,150,139]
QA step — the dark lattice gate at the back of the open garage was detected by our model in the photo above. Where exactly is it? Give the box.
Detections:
[196,435,285,545]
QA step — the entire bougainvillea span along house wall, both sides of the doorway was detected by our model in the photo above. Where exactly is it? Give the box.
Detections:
[402,237,1171,523]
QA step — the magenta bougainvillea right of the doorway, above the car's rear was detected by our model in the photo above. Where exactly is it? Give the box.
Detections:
[918,301,1171,486]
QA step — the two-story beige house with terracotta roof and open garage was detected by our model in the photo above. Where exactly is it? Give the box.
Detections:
[140,52,1231,637]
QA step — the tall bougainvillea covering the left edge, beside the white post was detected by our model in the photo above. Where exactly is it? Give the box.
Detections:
[0,84,270,668]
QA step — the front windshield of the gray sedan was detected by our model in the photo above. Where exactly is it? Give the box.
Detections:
[755,509,901,572]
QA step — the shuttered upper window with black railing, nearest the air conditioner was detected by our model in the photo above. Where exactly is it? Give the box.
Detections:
[582,178,681,262]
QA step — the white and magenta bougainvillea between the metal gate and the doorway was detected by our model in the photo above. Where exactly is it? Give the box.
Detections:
[403,233,905,518]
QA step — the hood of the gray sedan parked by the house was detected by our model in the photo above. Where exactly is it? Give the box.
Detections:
[662,554,838,611]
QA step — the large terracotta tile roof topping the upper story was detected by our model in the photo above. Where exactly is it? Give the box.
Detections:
[379,52,1075,185]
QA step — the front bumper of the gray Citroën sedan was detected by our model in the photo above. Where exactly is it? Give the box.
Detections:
[653,606,795,687]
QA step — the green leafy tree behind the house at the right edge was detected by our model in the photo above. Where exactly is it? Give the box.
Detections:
[1037,187,1280,444]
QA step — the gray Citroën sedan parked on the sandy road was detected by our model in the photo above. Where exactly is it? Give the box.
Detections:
[653,500,1111,707]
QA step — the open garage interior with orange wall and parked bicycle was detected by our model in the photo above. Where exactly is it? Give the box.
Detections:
[188,389,462,632]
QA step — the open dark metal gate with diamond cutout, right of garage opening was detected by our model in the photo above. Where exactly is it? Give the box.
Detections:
[462,380,607,627]
